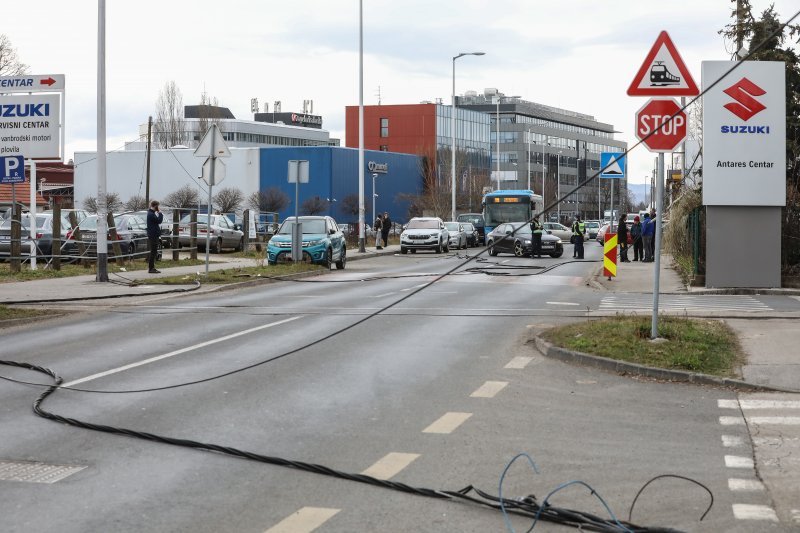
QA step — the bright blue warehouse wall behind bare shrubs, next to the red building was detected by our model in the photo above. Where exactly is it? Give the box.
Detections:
[259,146,422,224]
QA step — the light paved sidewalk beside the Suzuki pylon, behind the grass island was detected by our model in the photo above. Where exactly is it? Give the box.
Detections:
[590,249,800,391]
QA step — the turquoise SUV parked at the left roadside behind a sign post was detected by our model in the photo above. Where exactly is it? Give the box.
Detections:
[267,216,347,270]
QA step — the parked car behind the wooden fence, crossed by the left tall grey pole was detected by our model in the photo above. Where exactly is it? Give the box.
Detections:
[67,213,155,258]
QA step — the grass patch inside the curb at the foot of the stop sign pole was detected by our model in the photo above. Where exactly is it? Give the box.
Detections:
[542,316,744,377]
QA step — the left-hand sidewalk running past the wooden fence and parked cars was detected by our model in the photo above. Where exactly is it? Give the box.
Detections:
[0,245,400,305]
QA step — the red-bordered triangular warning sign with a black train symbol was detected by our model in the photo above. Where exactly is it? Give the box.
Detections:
[628,31,700,96]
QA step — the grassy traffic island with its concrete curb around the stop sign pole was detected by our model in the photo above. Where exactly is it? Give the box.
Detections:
[529,316,796,390]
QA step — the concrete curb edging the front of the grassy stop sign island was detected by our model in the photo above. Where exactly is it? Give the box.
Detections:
[528,326,800,393]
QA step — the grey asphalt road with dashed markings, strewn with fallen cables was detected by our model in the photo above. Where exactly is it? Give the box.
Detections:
[0,247,779,533]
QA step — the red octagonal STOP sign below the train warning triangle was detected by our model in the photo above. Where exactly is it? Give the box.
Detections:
[636,98,687,152]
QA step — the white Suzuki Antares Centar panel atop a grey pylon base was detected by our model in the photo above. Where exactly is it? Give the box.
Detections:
[703,61,786,206]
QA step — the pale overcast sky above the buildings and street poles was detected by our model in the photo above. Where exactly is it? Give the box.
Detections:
[1,0,800,182]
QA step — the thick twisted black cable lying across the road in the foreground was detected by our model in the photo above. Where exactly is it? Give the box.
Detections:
[0,361,692,533]
